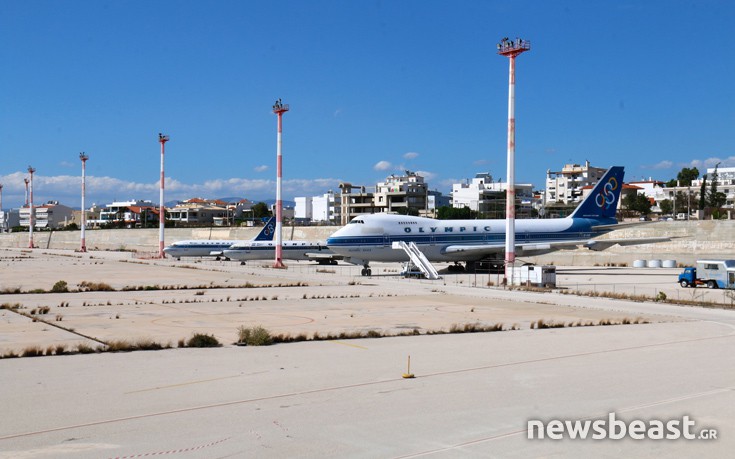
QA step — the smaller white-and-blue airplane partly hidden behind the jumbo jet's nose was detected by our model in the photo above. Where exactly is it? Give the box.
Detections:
[224,241,342,265]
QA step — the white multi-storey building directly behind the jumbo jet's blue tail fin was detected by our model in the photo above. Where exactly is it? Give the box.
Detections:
[545,161,607,204]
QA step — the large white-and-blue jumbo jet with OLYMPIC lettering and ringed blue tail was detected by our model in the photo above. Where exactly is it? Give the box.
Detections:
[327,166,669,276]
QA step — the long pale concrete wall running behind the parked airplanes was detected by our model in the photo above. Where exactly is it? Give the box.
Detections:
[0,221,735,266]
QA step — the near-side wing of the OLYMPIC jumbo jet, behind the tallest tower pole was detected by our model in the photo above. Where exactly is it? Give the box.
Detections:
[443,237,671,257]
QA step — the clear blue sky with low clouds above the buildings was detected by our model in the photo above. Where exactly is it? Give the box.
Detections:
[0,0,735,209]
